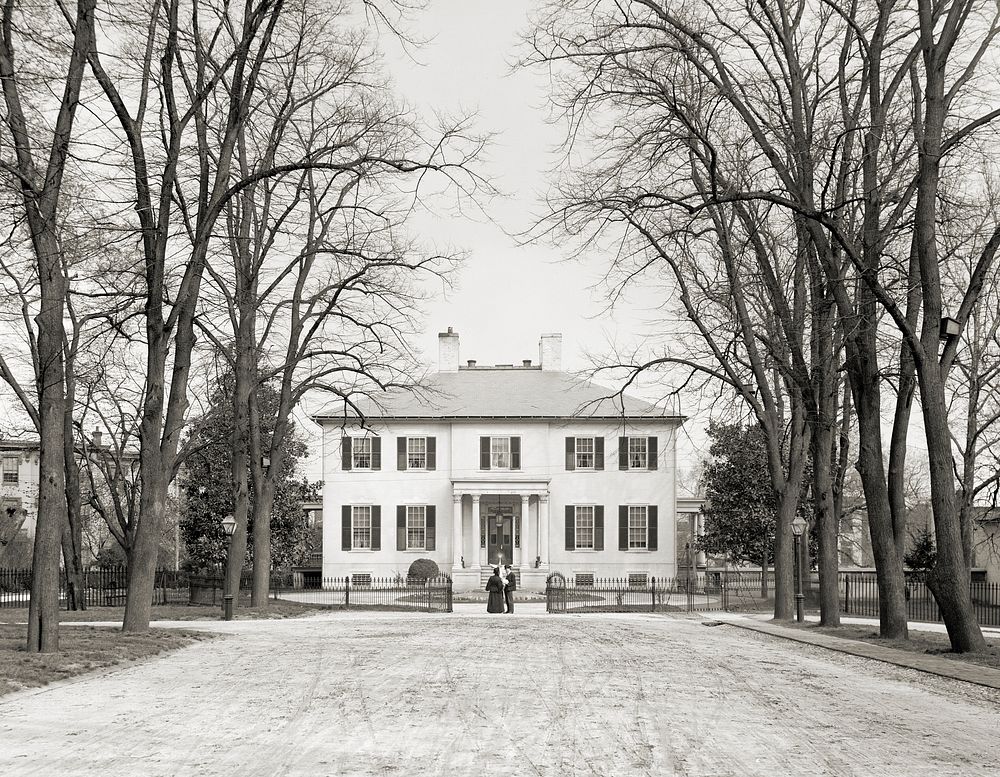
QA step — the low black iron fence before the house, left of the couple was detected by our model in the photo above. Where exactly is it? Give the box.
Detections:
[272,575,453,612]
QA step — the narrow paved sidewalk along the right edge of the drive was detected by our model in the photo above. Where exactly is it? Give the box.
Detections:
[705,612,1000,690]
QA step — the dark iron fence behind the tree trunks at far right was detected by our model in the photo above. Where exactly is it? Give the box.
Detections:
[839,572,1000,626]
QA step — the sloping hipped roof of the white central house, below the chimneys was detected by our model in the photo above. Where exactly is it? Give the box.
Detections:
[311,367,684,423]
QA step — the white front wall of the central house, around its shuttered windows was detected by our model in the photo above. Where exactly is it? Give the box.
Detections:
[323,421,676,578]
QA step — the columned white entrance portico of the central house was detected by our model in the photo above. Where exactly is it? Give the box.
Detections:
[452,477,549,590]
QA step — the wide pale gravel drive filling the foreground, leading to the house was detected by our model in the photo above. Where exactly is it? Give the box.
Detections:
[0,613,1000,777]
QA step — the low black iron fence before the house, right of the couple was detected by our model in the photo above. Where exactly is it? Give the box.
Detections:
[545,572,767,612]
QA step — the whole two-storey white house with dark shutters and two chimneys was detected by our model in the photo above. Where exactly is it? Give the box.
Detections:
[313,329,700,590]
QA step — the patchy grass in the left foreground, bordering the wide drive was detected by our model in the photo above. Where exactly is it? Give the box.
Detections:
[0,624,213,696]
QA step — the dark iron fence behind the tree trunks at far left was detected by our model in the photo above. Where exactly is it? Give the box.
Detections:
[0,567,189,608]
